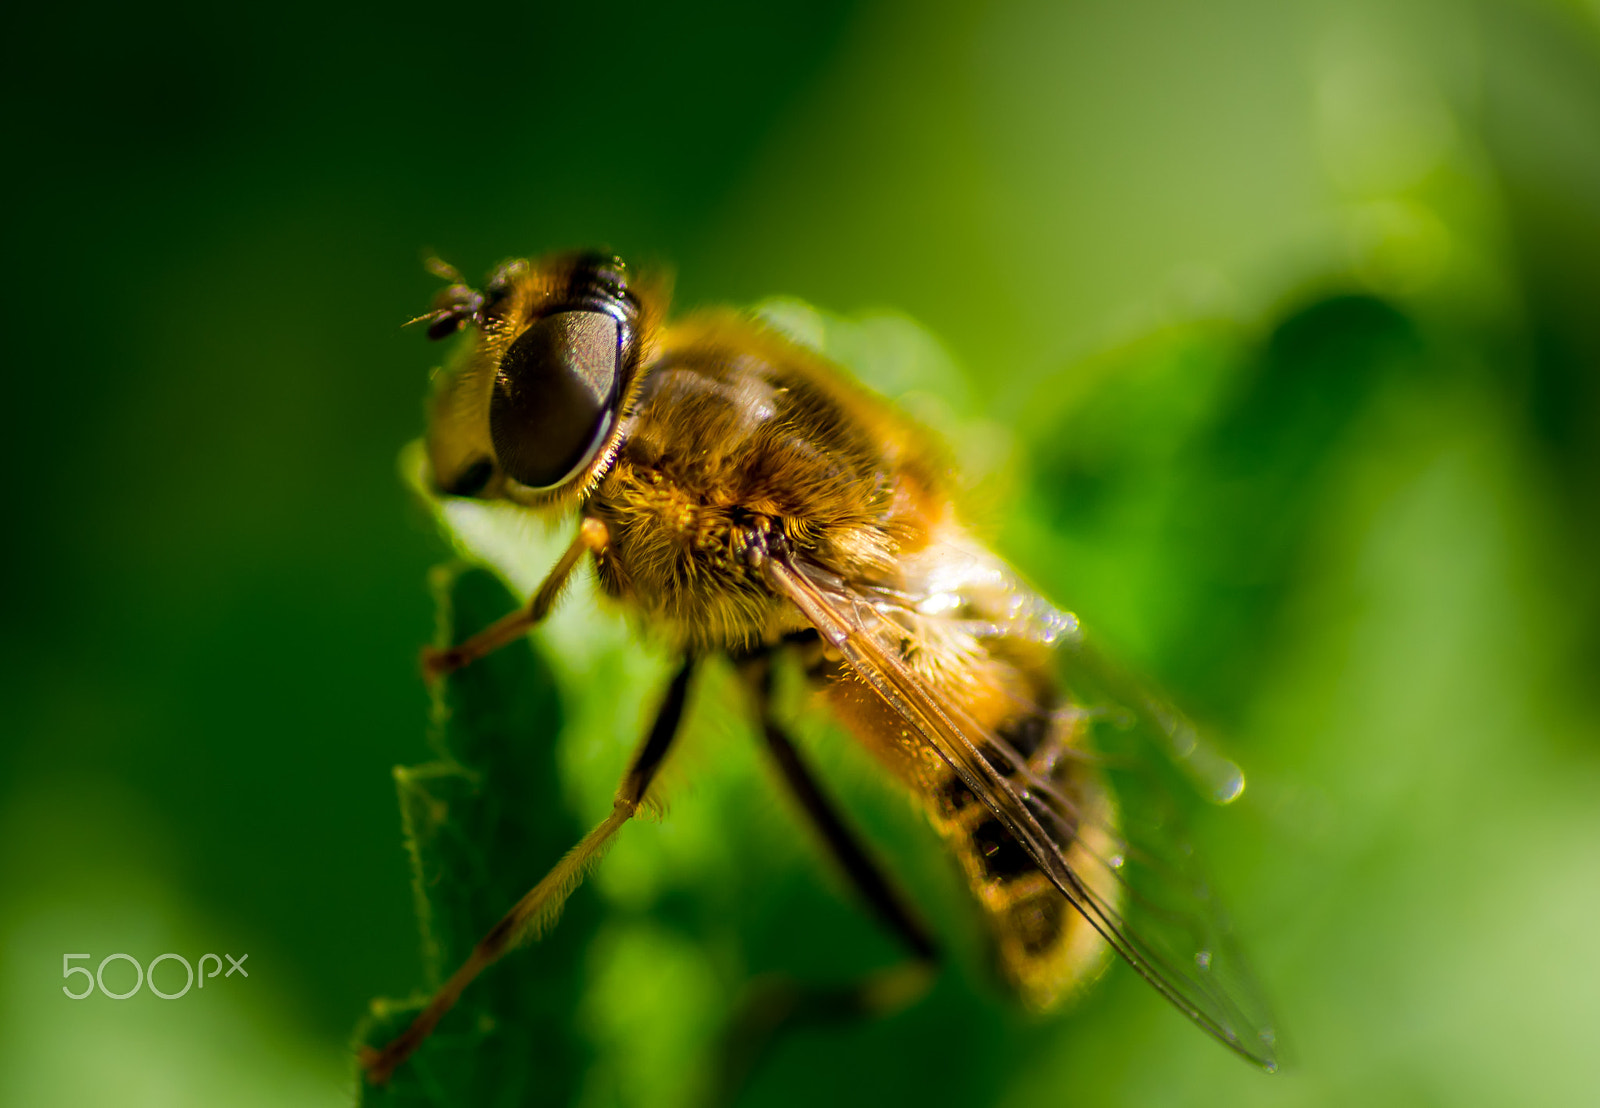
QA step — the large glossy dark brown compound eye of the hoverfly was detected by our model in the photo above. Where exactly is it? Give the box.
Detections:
[490,311,622,488]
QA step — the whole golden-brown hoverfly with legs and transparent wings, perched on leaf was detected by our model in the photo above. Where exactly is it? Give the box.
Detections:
[362,253,1277,1081]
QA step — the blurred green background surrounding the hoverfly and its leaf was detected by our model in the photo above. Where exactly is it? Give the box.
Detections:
[0,0,1600,1106]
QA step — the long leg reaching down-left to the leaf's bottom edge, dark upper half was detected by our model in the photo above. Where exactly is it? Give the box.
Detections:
[362,658,694,1084]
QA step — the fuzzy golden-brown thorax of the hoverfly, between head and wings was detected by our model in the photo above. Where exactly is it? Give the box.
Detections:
[586,317,949,652]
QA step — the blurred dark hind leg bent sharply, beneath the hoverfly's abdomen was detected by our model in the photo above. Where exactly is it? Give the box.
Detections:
[717,653,939,1103]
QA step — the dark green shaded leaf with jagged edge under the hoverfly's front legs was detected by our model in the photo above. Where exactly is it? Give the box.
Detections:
[357,567,598,1108]
